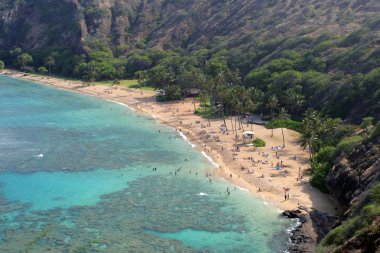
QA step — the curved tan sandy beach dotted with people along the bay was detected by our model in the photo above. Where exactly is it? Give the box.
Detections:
[0,70,339,248]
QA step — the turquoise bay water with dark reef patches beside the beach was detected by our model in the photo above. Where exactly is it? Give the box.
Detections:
[0,75,292,253]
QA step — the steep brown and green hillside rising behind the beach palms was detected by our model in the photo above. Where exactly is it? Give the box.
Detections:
[0,0,380,121]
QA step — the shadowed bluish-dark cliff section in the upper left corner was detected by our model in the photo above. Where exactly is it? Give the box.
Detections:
[0,0,81,50]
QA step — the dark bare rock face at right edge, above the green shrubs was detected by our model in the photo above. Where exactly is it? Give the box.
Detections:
[326,138,380,208]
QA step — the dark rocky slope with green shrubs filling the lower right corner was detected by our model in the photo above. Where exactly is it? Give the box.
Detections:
[319,127,380,253]
